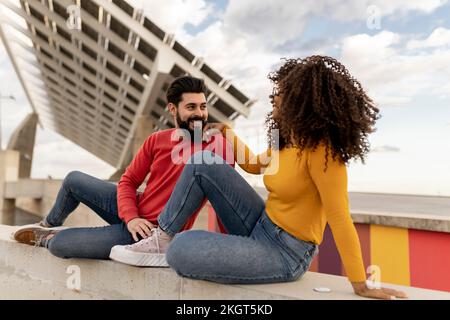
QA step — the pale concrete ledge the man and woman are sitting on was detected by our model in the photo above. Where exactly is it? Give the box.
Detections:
[0,225,450,300]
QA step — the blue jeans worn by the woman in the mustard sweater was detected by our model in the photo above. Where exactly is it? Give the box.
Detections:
[158,151,317,284]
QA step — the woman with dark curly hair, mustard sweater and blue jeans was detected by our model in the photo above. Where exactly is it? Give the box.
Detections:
[111,56,406,299]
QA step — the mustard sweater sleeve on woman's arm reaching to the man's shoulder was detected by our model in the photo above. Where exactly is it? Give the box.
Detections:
[222,127,271,174]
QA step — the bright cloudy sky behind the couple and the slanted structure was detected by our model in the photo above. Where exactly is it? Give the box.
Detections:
[0,0,450,196]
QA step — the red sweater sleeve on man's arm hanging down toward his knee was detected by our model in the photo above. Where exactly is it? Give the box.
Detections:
[117,134,156,223]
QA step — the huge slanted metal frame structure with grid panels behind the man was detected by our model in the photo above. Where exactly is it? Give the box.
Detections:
[0,0,254,169]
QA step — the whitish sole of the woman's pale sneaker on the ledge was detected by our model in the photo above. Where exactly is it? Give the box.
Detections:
[109,246,169,268]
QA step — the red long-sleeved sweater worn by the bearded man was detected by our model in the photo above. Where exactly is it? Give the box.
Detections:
[117,129,234,230]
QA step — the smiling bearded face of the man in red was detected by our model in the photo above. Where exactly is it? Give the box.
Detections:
[169,93,208,138]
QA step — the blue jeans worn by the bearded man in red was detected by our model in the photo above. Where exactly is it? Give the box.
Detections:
[45,171,135,259]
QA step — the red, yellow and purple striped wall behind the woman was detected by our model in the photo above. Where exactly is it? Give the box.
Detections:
[208,207,450,291]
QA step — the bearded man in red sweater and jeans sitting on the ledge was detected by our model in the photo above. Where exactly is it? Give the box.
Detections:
[13,76,234,259]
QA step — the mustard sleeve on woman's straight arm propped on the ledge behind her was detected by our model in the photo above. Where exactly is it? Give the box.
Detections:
[308,145,366,282]
